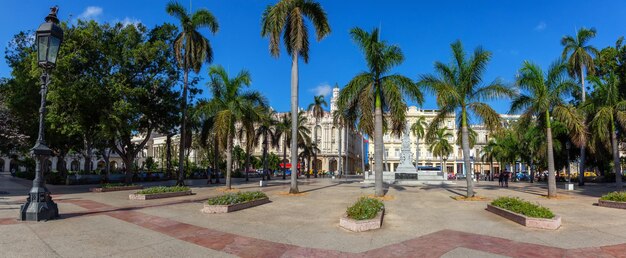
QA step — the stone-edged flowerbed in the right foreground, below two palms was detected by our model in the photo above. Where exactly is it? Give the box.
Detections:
[487,197,561,229]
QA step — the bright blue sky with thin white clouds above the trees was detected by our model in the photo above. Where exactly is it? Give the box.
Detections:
[0,0,626,123]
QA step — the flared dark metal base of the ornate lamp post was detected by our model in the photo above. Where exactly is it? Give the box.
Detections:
[20,186,59,221]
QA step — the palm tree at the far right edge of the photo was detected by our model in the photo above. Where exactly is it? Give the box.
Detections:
[590,74,626,189]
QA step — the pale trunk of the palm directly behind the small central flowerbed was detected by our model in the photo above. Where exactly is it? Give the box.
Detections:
[374,88,385,196]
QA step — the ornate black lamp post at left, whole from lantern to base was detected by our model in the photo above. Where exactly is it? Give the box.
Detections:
[20,6,63,221]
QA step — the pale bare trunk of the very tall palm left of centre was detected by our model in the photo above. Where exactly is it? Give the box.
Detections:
[289,51,300,193]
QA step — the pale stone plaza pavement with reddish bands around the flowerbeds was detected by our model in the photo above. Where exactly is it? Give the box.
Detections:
[0,176,626,257]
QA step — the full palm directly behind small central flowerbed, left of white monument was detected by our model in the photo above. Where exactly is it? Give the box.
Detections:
[338,28,423,196]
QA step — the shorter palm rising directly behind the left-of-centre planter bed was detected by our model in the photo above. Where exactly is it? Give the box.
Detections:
[207,66,268,189]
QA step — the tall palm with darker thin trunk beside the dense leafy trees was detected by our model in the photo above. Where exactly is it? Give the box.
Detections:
[165,2,219,185]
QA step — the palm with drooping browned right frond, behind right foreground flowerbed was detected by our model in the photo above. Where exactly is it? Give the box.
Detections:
[511,60,584,197]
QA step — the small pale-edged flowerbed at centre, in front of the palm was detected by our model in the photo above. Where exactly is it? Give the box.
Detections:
[339,197,385,232]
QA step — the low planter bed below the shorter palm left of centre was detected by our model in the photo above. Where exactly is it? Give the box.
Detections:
[202,191,269,213]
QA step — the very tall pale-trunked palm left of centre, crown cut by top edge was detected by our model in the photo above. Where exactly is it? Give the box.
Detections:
[261,0,330,193]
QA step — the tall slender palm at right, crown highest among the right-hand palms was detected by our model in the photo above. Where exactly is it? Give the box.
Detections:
[561,28,600,185]
